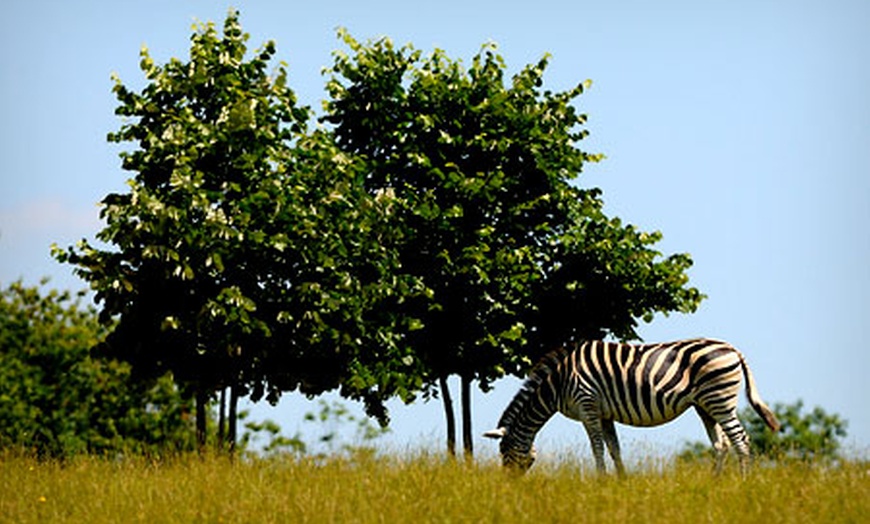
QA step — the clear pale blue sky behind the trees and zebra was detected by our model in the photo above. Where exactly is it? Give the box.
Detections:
[0,0,870,458]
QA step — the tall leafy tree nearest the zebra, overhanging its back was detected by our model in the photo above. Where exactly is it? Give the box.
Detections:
[324,31,701,454]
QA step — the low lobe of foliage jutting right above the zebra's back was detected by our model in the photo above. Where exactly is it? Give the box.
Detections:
[528,189,704,350]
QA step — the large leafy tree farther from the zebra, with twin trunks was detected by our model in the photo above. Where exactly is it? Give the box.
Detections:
[55,11,421,447]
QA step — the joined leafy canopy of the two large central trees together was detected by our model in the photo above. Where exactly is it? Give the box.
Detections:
[55,11,702,454]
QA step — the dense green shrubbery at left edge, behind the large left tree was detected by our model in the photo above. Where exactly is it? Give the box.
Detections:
[0,281,194,458]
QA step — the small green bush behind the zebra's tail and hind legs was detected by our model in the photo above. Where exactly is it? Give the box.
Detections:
[679,400,848,461]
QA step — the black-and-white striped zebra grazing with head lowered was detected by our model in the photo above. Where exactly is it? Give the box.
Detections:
[484,338,780,476]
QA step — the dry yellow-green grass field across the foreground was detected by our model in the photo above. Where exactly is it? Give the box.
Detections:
[0,454,870,524]
